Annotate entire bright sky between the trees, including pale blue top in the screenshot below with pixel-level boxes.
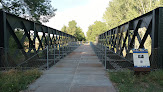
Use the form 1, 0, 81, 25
45, 0, 110, 35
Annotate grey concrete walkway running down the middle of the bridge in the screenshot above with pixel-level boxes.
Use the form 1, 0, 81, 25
29, 45, 115, 92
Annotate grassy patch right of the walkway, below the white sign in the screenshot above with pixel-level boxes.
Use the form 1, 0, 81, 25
109, 70, 163, 92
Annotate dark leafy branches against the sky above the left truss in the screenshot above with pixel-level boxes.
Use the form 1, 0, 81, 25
1, 0, 56, 23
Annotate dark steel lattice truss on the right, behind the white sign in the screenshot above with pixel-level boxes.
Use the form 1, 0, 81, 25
98, 7, 163, 68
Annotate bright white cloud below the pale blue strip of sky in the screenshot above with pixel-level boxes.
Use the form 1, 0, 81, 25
45, 0, 110, 34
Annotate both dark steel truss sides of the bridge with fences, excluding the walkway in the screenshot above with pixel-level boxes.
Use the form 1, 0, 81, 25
0, 7, 163, 70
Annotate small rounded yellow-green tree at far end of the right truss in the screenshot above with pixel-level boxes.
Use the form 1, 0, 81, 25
87, 21, 107, 42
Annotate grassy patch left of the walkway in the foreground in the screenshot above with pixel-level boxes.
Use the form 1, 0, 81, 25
0, 69, 42, 92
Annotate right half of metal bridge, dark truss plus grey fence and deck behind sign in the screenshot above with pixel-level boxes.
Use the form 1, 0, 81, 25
92, 7, 163, 69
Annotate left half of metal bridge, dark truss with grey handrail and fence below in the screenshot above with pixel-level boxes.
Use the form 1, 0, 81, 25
0, 11, 79, 68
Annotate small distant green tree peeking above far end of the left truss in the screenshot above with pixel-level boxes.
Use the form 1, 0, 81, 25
61, 20, 85, 41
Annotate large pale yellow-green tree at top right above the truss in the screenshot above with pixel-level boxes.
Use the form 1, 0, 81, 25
103, 0, 163, 29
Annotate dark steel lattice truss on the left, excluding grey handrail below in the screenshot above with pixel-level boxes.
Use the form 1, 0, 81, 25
0, 11, 76, 67
